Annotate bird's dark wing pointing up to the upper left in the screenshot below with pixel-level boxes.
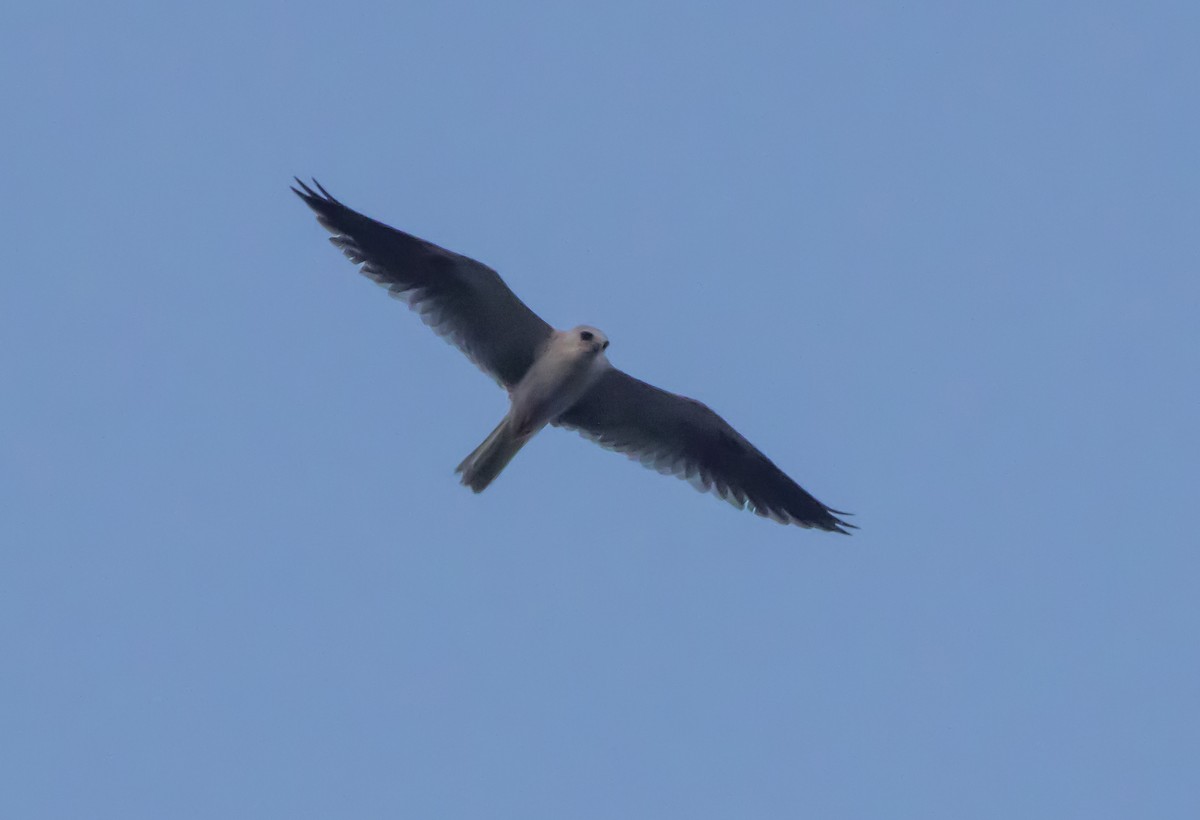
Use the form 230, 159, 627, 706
292, 179, 552, 388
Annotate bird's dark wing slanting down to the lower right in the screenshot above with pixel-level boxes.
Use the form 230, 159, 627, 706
554, 369, 854, 534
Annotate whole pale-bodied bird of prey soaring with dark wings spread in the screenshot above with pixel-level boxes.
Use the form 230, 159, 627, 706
292, 179, 854, 534
